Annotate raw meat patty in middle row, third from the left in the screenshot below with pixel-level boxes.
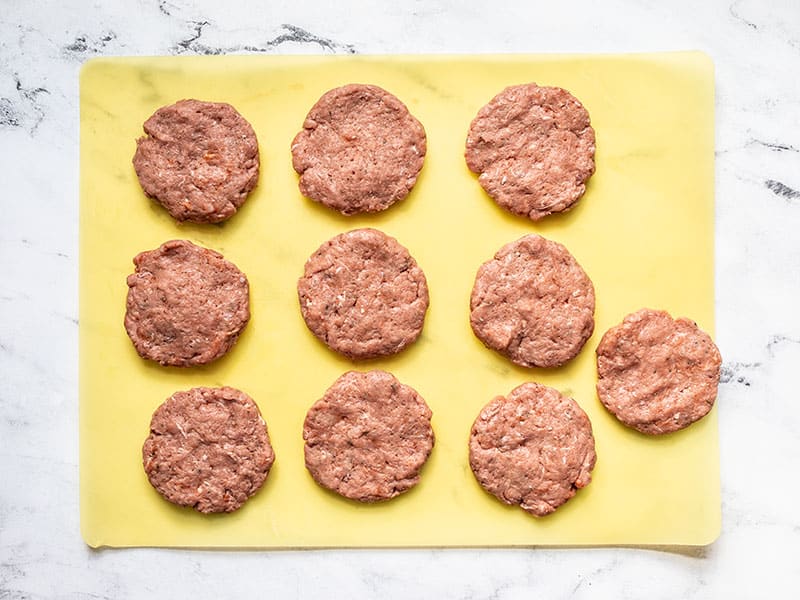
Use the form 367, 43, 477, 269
470, 235, 594, 367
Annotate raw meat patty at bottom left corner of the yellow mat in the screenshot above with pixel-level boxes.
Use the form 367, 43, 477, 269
142, 387, 275, 513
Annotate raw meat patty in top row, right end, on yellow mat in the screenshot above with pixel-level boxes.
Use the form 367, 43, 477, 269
466, 83, 595, 221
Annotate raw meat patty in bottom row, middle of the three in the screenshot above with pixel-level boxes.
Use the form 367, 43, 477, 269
303, 371, 434, 502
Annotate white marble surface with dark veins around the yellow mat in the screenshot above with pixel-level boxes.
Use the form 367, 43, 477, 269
0, 0, 800, 599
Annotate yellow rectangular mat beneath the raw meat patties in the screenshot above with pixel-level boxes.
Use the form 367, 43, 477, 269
80, 52, 720, 547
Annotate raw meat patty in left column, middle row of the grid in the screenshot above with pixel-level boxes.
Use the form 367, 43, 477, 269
125, 240, 250, 367
